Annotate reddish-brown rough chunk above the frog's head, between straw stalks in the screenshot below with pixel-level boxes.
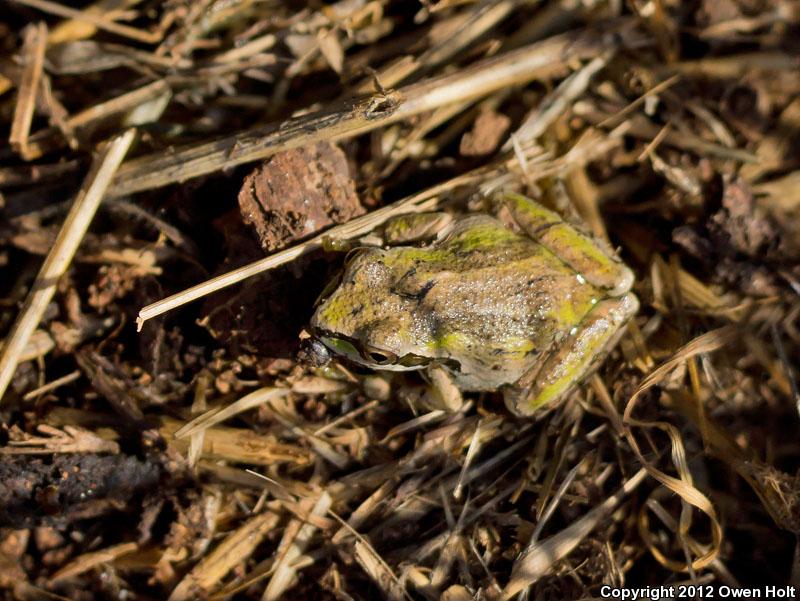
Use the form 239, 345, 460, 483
239, 142, 364, 251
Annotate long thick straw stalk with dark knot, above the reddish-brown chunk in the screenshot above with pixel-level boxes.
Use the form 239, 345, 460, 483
112, 25, 630, 196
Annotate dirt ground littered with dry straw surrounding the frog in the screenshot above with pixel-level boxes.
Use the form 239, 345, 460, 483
0, 0, 800, 601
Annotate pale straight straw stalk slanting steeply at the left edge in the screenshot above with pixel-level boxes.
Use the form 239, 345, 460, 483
0, 129, 136, 401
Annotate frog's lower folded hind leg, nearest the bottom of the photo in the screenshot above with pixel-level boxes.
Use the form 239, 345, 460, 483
504, 294, 639, 415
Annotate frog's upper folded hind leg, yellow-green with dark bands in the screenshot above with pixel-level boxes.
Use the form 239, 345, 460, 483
503, 193, 633, 296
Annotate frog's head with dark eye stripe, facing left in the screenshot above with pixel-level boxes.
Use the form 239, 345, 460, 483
310, 248, 438, 371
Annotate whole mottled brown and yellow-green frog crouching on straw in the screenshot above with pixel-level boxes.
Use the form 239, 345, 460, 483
310, 192, 639, 416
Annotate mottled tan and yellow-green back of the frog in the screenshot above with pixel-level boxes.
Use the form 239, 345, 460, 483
393, 215, 598, 389
